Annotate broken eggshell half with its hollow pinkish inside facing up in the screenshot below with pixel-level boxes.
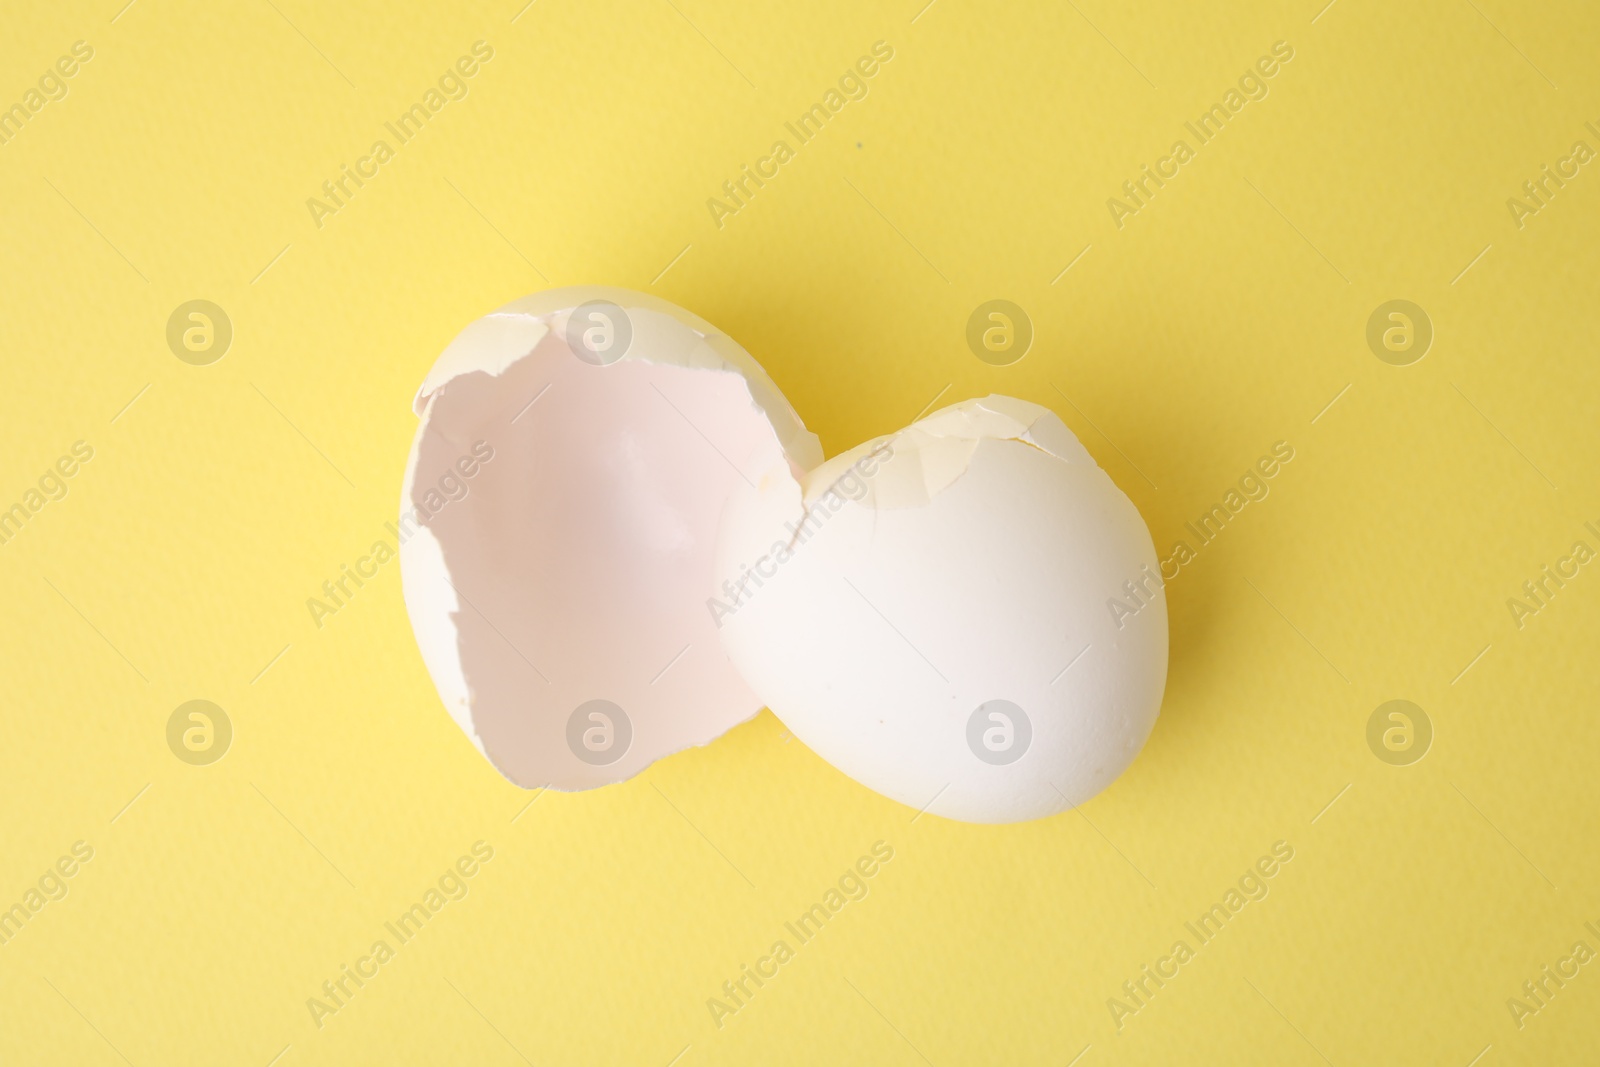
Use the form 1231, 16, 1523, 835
400, 286, 822, 789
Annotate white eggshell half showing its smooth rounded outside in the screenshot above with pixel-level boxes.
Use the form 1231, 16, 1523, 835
712, 397, 1166, 822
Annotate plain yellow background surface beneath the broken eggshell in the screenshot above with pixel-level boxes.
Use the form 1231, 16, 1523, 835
0, 0, 1600, 1067
